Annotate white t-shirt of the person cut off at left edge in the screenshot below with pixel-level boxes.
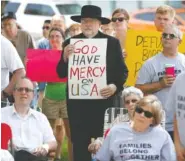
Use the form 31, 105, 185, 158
1, 35, 24, 91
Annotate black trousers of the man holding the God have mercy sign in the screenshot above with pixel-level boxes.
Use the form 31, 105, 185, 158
67, 99, 113, 161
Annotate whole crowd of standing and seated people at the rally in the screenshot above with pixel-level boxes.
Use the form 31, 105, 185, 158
1, 5, 185, 161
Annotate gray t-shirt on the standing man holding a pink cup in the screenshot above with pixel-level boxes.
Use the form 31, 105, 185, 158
136, 53, 185, 131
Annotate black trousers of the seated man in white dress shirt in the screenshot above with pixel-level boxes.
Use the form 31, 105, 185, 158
14, 150, 48, 161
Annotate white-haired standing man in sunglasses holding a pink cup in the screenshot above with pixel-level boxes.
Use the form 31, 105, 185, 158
136, 24, 185, 138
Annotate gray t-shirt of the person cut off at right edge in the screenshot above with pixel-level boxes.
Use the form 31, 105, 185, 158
166, 72, 185, 148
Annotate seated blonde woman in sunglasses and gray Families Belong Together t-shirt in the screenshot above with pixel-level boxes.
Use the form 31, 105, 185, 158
95, 95, 176, 161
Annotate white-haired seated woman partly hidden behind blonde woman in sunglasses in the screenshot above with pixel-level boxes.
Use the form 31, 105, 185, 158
88, 86, 143, 153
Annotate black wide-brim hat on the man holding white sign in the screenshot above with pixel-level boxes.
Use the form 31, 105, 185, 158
71, 5, 110, 24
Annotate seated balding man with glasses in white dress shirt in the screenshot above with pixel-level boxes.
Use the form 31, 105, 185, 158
1, 78, 57, 161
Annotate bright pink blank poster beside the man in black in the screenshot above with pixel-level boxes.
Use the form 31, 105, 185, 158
26, 49, 67, 82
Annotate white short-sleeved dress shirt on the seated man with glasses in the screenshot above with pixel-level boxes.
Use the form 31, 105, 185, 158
1, 106, 56, 153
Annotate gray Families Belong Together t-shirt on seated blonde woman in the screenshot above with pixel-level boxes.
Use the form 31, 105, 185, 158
95, 123, 176, 161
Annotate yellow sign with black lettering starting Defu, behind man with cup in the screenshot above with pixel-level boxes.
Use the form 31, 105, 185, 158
125, 30, 185, 86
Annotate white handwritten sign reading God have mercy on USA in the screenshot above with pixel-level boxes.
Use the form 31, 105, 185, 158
68, 39, 107, 99
